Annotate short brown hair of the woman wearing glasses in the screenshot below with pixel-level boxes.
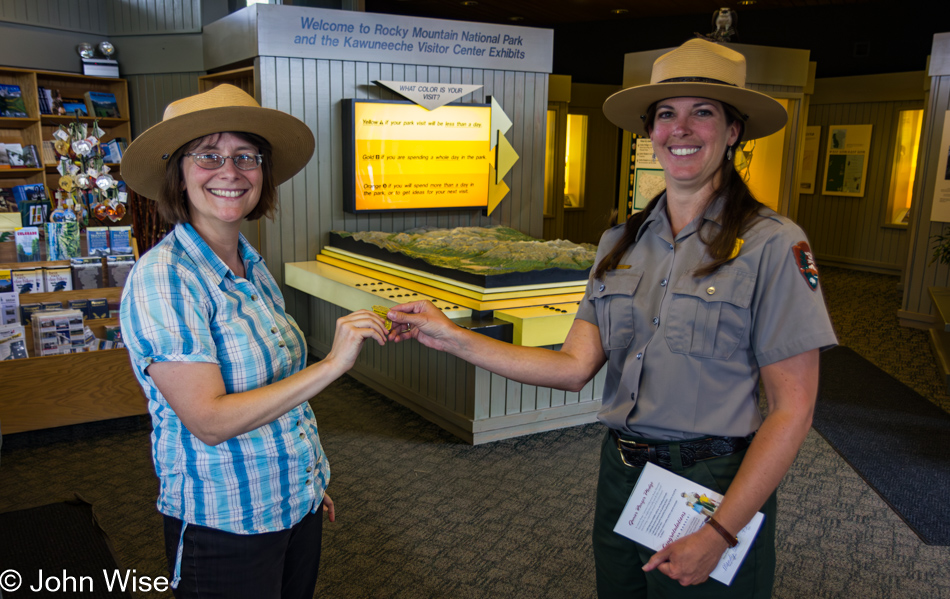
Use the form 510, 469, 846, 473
155, 131, 277, 224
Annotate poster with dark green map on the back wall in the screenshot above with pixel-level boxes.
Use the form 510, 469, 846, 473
821, 125, 871, 198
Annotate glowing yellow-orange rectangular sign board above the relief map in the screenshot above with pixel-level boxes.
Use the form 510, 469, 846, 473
343, 100, 493, 212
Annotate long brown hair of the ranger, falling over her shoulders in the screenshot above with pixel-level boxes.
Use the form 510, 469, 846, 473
594, 102, 763, 279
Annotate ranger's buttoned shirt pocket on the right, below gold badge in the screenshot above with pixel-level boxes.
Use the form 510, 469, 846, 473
666, 267, 756, 360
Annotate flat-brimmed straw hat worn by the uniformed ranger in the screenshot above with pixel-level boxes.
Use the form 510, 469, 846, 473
604, 38, 788, 141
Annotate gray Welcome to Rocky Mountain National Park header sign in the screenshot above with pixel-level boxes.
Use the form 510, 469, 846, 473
245, 4, 554, 73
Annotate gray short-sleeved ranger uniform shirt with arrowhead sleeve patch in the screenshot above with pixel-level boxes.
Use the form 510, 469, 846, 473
577, 195, 837, 440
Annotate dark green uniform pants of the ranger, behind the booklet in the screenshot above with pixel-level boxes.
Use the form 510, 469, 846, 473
593, 431, 777, 599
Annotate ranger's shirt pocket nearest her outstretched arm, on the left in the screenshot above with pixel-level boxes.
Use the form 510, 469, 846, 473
588, 270, 643, 351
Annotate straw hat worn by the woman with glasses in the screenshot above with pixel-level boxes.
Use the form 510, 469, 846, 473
122, 84, 314, 200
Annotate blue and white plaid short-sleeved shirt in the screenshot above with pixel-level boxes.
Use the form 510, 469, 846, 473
120, 224, 330, 534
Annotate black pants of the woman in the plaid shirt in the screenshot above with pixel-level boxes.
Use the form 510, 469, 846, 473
165, 509, 323, 599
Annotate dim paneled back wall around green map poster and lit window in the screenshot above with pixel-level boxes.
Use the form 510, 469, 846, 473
796, 99, 923, 274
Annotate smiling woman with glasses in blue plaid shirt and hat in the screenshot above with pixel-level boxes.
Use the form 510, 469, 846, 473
121, 85, 386, 599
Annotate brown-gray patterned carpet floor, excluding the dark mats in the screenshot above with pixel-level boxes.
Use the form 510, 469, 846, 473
0, 268, 950, 599
